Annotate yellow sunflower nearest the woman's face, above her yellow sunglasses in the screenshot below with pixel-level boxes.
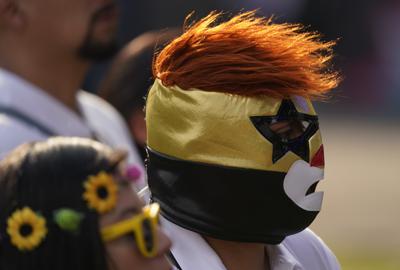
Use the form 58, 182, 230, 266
83, 172, 118, 214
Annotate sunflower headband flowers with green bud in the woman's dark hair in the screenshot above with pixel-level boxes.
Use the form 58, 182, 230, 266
7, 167, 139, 251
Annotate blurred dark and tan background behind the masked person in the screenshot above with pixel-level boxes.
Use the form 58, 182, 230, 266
83, 0, 400, 270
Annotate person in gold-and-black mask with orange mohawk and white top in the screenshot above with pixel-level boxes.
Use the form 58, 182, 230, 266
146, 12, 340, 270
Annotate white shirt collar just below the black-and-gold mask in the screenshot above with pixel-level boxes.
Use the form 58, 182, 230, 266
161, 218, 303, 270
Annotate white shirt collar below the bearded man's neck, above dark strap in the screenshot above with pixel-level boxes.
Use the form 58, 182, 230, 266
0, 68, 92, 137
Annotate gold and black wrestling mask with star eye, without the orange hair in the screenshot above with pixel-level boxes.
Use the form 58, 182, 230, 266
146, 80, 324, 244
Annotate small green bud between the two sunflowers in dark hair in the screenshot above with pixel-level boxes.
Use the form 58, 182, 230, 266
53, 208, 85, 233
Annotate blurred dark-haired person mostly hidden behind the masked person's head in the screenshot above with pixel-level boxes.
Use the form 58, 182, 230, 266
98, 29, 179, 160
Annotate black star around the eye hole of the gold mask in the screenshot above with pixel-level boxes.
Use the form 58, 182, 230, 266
250, 99, 319, 163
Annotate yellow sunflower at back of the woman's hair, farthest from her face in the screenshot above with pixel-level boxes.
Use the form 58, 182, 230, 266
7, 207, 47, 251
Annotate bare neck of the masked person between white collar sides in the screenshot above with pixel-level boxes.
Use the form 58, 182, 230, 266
205, 237, 270, 270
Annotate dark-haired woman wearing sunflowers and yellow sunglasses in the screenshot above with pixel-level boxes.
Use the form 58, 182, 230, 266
0, 137, 171, 270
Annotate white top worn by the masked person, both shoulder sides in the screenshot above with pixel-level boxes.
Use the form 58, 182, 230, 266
162, 218, 340, 270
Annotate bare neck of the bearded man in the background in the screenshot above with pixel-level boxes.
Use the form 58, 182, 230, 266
0, 46, 89, 113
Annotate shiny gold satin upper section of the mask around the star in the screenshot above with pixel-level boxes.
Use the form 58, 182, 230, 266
146, 80, 322, 172
